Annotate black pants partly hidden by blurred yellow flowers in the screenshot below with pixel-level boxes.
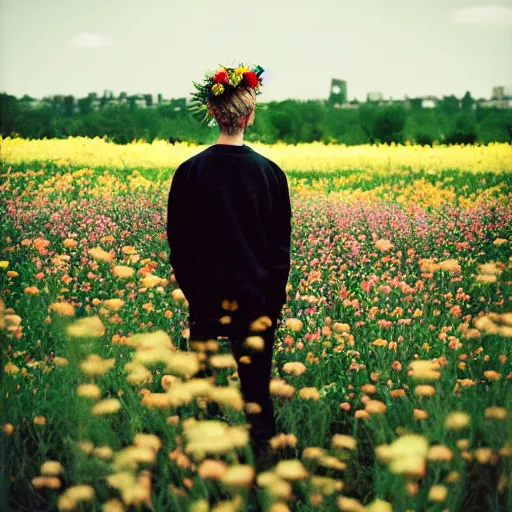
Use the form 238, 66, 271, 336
189, 315, 276, 445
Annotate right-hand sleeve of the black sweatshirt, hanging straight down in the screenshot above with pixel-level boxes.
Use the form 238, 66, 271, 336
268, 171, 292, 315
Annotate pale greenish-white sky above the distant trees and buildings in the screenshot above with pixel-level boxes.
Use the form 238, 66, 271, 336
0, 0, 512, 102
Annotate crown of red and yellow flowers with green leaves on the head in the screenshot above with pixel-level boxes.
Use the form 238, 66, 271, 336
189, 64, 264, 126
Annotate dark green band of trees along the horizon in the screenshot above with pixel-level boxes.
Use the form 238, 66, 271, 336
0, 93, 512, 145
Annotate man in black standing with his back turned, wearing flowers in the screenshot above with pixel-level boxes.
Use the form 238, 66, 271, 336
167, 67, 292, 464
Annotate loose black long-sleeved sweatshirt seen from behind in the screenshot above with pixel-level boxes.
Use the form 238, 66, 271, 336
167, 144, 292, 318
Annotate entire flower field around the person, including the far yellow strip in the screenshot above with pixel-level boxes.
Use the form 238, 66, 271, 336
0, 139, 512, 512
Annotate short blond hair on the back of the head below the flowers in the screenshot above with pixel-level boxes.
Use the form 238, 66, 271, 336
208, 87, 256, 135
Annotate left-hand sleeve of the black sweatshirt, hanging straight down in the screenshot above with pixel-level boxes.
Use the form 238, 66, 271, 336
167, 166, 196, 302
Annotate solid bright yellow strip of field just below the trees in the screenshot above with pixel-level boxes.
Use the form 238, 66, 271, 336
0, 137, 512, 173
